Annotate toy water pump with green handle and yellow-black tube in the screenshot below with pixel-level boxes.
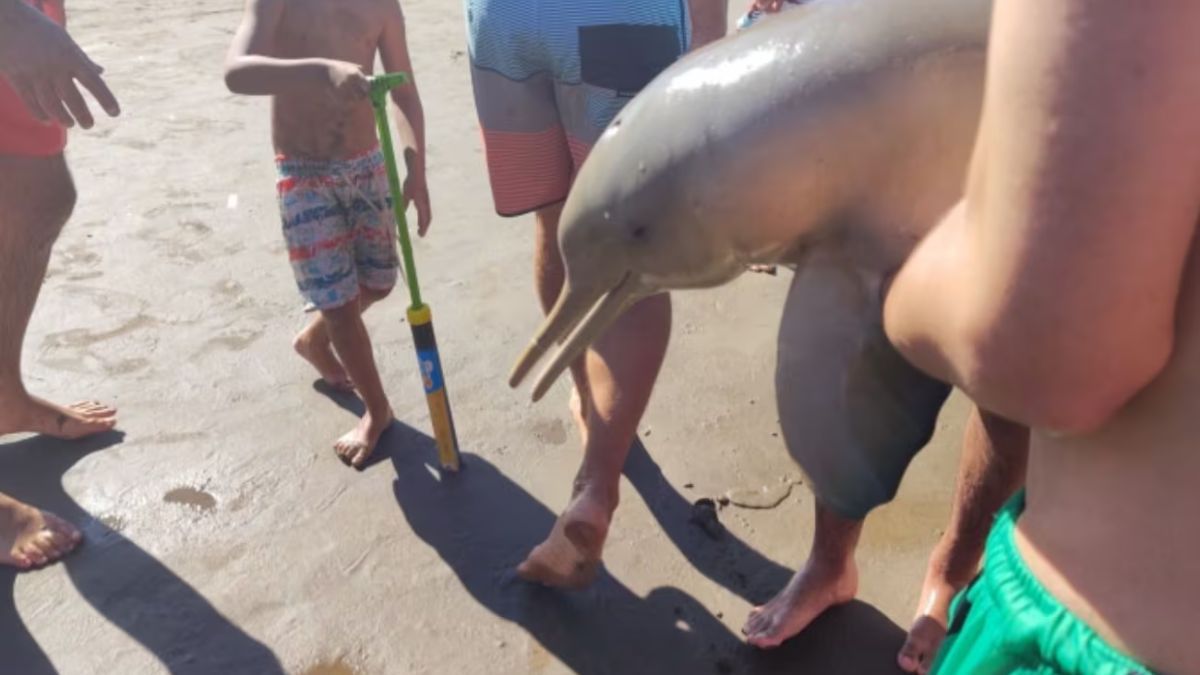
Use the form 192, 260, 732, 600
371, 72, 462, 471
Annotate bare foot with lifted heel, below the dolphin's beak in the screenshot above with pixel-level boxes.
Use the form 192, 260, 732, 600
517, 488, 617, 591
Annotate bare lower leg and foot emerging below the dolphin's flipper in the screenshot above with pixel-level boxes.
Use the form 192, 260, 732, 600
742, 501, 863, 649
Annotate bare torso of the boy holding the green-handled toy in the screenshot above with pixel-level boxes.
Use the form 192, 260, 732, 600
271, 0, 385, 159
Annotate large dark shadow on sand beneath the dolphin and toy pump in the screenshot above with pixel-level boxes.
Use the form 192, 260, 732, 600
376, 413, 904, 675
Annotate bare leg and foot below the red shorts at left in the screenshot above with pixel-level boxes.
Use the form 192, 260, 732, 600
0, 155, 116, 439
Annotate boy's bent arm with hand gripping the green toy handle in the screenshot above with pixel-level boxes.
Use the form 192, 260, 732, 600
226, 0, 371, 98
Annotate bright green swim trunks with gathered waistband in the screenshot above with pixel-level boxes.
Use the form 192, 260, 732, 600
930, 491, 1152, 675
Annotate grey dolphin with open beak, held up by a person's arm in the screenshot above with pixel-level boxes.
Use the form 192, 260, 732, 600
510, 0, 991, 518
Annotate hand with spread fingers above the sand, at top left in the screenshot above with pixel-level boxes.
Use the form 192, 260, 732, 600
0, 2, 121, 129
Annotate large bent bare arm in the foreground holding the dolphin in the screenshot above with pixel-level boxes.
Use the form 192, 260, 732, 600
884, 0, 1200, 431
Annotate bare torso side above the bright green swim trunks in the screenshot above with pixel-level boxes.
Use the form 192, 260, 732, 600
1016, 229, 1200, 674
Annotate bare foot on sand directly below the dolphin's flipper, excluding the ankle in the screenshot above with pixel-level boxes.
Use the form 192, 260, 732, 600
742, 560, 858, 649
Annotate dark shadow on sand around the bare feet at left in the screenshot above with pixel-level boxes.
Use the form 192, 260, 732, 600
0, 432, 283, 675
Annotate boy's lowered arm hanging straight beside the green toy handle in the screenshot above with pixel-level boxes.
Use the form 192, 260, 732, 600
379, 0, 432, 237
